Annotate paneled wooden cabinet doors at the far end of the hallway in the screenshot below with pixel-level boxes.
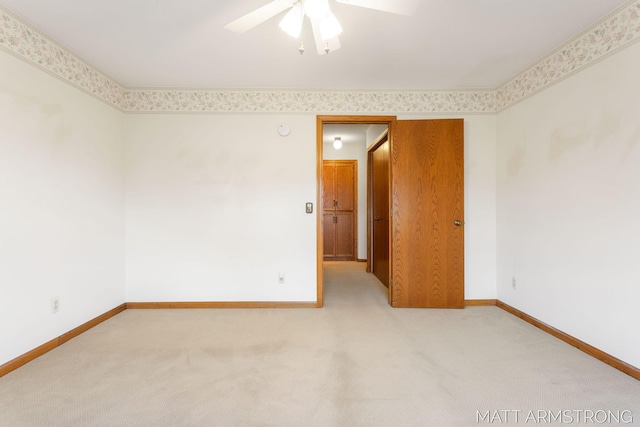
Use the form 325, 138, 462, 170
322, 160, 357, 261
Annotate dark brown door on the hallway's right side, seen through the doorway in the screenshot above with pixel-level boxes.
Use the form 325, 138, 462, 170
370, 140, 389, 287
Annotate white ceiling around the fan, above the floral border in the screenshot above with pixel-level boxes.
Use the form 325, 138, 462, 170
0, 0, 628, 90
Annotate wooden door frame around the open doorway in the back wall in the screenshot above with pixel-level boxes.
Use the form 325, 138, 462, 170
316, 115, 396, 308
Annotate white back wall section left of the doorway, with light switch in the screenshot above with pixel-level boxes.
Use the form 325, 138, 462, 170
126, 114, 317, 301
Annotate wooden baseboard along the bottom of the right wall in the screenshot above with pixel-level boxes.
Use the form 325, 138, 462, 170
496, 300, 640, 380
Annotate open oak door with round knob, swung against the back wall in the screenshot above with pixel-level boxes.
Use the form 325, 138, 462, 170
391, 119, 464, 308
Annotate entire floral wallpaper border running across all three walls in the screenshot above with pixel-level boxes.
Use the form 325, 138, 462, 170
0, 0, 640, 114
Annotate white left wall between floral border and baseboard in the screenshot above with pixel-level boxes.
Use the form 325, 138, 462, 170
0, 51, 125, 364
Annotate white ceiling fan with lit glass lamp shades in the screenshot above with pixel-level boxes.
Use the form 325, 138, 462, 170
225, 0, 420, 55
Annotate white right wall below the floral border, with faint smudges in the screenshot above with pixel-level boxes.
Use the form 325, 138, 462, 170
497, 44, 640, 367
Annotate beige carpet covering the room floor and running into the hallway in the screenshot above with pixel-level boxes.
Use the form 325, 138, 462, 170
0, 262, 640, 427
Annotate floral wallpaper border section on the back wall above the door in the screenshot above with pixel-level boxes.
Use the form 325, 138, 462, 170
124, 89, 496, 114
